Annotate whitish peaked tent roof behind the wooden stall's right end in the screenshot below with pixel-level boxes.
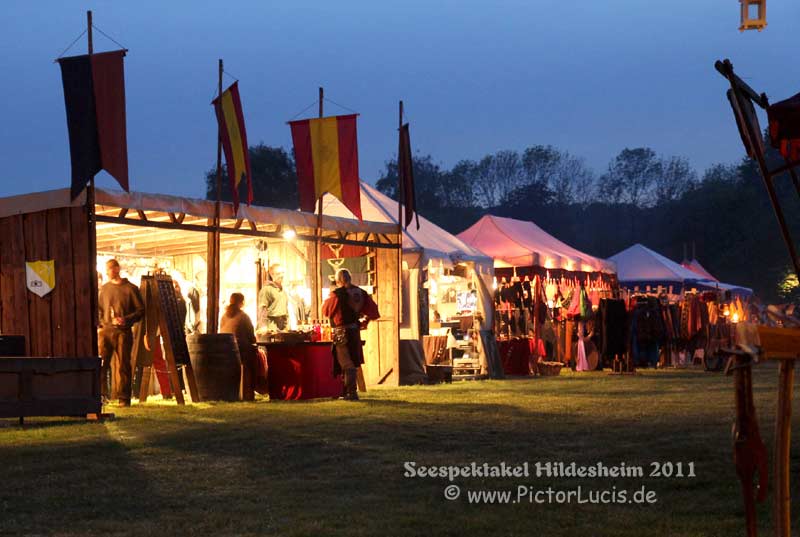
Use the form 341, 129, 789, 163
322, 181, 492, 268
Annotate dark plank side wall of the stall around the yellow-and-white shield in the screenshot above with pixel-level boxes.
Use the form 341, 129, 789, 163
0, 195, 97, 357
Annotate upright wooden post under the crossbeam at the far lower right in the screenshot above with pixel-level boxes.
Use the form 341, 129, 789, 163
773, 360, 794, 537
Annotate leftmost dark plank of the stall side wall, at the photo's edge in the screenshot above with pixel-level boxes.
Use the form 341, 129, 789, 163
0, 215, 30, 355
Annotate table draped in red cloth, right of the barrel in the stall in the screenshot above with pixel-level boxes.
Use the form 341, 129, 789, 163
258, 342, 342, 400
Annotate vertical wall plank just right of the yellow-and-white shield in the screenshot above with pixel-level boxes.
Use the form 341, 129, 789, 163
47, 209, 77, 356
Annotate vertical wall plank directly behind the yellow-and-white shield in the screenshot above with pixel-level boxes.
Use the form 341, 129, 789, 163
22, 211, 53, 356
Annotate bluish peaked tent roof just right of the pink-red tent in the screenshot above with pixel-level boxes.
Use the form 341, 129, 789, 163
608, 244, 753, 295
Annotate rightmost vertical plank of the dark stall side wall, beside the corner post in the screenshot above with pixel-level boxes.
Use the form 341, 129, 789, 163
70, 207, 97, 356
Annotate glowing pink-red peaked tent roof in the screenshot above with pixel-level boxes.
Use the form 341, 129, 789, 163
458, 215, 616, 274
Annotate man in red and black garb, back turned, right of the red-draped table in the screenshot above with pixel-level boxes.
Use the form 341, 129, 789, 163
322, 269, 380, 401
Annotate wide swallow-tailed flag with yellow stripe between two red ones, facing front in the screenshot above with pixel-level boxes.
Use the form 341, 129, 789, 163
289, 114, 361, 220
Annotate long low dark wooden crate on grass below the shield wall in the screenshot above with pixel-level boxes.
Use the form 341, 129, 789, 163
0, 357, 102, 418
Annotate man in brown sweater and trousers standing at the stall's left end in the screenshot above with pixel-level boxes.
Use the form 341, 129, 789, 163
97, 259, 144, 406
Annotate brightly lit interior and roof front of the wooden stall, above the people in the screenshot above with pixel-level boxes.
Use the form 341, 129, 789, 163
95, 190, 400, 384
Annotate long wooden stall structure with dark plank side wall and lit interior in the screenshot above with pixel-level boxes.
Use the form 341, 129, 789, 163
0, 189, 400, 385
